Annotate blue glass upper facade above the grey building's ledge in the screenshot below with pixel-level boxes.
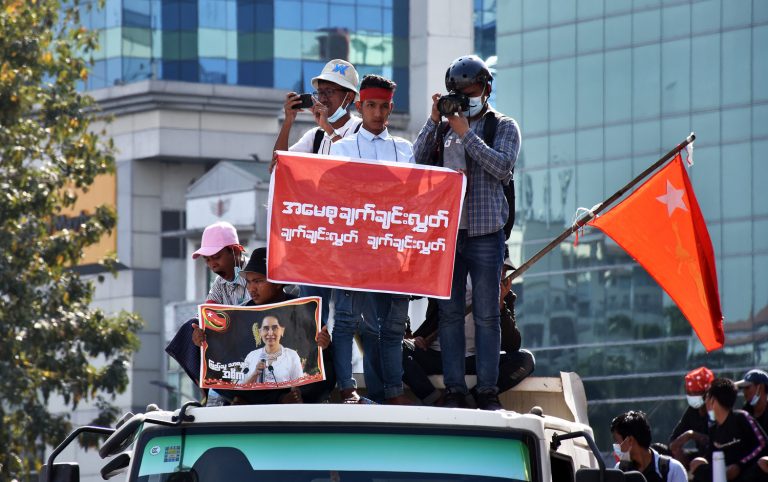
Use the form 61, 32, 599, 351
83, 0, 409, 110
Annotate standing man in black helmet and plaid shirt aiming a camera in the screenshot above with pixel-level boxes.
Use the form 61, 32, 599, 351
414, 55, 520, 410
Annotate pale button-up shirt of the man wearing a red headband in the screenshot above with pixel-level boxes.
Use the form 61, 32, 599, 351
331, 127, 413, 163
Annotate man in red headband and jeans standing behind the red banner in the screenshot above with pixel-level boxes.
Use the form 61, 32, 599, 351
331, 75, 413, 404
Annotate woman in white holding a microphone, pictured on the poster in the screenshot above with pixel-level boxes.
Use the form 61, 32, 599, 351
238, 316, 304, 385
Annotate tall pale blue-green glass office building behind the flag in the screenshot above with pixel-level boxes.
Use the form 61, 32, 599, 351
492, 0, 768, 450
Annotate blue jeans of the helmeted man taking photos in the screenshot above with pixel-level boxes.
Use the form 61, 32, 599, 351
437, 229, 504, 393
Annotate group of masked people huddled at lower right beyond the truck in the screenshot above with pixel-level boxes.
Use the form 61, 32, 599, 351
611, 367, 768, 482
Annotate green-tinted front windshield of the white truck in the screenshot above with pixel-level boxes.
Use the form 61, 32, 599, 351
132, 428, 532, 482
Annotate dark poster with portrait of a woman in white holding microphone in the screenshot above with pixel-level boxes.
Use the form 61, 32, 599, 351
198, 297, 325, 390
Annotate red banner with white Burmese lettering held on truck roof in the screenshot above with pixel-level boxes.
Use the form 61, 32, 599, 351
267, 151, 466, 298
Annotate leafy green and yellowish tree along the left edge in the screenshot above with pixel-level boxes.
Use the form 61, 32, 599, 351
0, 0, 140, 480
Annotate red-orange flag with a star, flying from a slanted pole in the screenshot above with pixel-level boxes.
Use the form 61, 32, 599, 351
590, 153, 725, 351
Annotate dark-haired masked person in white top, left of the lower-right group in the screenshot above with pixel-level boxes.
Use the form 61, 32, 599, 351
611, 411, 688, 482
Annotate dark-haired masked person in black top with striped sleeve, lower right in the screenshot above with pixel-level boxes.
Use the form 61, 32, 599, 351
691, 378, 768, 482
